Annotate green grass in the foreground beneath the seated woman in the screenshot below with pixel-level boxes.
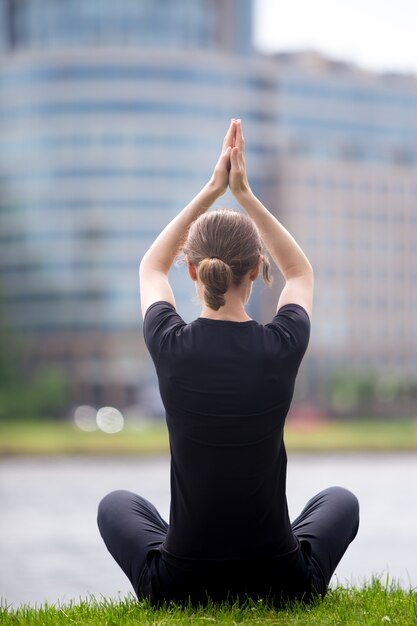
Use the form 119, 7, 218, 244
0, 579, 417, 626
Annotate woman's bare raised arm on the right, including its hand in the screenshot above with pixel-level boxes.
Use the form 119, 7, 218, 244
229, 121, 314, 316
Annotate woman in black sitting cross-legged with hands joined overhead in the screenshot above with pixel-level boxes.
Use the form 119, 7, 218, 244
98, 120, 359, 603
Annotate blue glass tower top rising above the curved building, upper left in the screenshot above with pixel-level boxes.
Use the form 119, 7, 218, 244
0, 0, 252, 55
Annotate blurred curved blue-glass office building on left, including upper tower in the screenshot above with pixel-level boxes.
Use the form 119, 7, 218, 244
0, 0, 276, 406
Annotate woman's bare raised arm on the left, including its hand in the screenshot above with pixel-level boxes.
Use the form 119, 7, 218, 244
139, 121, 234, 317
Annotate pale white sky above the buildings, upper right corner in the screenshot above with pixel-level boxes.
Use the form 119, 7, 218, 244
255, 0, 417, 74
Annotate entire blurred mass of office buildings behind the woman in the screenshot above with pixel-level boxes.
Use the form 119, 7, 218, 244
0, 0, 417, 406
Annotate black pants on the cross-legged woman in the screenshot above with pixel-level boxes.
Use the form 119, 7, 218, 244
98, 487, 359, 603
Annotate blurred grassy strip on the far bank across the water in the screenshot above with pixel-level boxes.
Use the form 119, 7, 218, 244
0, 419, 417, 456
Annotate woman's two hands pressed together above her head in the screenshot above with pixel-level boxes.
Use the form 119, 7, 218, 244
212, 119, 250, 197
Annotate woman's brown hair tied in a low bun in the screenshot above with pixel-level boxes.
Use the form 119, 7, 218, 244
183, 209, 271, 311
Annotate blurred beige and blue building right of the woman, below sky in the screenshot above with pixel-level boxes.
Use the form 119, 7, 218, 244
275, 53, 417, 399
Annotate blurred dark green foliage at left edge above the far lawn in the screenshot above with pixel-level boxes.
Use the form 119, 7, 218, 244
0, 298, 71, 420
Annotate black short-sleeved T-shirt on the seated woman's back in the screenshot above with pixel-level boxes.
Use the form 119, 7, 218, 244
144, 302, 309, 564
